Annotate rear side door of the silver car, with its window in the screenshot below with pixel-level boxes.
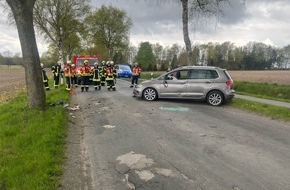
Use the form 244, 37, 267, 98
186, 69, 219, 99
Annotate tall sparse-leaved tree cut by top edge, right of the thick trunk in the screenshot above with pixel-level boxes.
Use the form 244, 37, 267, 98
34, 0, 90, 61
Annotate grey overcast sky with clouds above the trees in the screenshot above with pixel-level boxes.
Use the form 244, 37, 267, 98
0, 0, 290, 53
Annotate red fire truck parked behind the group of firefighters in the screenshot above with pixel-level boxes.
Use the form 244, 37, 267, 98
73, 55, 99, 84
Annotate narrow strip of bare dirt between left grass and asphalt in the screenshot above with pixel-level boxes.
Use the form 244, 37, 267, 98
59, 94, 92, 190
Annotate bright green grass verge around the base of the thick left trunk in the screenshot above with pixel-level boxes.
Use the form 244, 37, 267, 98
0, 86, 69, 190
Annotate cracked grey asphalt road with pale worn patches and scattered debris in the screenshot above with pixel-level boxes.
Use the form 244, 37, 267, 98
60, 80, 290, 190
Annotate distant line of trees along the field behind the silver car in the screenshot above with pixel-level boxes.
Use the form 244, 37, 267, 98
135, 42, 290, 71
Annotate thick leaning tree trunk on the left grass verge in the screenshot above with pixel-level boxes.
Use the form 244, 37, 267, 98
6, 0, 46, 110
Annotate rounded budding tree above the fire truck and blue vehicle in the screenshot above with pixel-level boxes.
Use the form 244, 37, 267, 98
85, 5, 133, 58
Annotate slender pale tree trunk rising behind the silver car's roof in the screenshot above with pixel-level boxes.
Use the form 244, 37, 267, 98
180, 0, 193, 65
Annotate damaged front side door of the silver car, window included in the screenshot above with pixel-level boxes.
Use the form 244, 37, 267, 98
159, 69, 188, 98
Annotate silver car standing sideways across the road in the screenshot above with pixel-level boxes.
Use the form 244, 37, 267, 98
133, 66, 235, 106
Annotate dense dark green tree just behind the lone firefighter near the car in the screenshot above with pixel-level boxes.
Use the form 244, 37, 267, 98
135, 42, 156, 71
